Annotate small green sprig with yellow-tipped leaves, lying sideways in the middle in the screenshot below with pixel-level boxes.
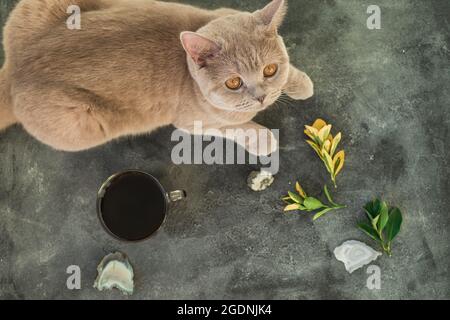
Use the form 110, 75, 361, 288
283, 182, 346, 221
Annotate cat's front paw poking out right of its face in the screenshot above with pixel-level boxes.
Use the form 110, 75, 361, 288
283, 65, 314, 100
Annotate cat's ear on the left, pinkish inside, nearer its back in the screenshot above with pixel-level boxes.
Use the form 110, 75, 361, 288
180, 31, 221, 67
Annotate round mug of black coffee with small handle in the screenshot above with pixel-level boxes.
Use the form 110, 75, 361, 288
97, 170, 186, 242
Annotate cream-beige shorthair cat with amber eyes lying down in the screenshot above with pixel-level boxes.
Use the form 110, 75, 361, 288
0, 0, 313, 155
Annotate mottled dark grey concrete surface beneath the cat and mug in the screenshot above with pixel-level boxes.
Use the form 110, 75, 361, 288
0, 0, 450, 299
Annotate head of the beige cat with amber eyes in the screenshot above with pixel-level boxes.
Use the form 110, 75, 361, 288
181, 0, 289, 112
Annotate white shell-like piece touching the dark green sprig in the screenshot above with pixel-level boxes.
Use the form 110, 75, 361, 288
334, 240, 382, 273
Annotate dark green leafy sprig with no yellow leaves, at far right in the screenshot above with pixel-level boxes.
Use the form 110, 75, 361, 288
358, 199, 403, 256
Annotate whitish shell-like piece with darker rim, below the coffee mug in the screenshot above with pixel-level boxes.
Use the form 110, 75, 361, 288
94, 252, 134, 295
